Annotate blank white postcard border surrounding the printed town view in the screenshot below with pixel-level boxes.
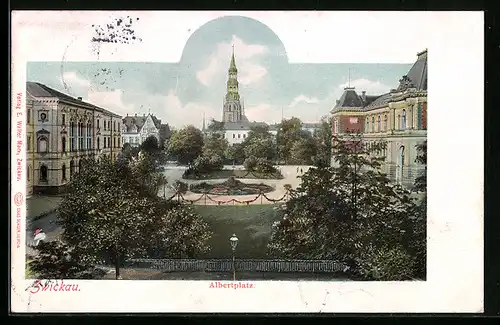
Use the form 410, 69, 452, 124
11, 11, 484, 313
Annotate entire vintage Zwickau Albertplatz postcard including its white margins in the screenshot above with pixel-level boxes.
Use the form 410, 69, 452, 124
11, 11, 484, 313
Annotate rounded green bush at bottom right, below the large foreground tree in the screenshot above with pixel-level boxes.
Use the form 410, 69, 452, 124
357, 247, 415, 281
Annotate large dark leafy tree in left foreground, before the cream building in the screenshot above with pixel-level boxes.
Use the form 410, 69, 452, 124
58, 156, 212, 278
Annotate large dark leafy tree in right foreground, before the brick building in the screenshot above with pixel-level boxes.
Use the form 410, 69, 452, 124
269, 135, 424, 277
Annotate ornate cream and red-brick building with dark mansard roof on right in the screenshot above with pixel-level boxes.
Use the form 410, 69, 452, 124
331, 50, 427, 187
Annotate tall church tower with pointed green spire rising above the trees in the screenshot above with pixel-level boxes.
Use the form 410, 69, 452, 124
222, 45, 247, 123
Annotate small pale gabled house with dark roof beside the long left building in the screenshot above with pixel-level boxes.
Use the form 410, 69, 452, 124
121, 114, 171, 147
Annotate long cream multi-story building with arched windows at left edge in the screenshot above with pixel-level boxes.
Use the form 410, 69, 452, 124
26, 82, 121, 195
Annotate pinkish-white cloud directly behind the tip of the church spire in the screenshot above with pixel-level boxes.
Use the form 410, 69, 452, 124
196, 35, 268, 86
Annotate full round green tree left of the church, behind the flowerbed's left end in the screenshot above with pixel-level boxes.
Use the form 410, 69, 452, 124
166, 125, 203, 165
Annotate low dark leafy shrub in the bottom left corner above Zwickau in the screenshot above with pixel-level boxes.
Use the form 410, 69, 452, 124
29, 240, 92, 279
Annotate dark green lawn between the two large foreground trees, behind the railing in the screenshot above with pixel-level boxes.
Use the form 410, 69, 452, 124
195, 204, 278, 259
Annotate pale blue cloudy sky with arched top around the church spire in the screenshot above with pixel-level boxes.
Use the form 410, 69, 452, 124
27, 16, 412, 127
